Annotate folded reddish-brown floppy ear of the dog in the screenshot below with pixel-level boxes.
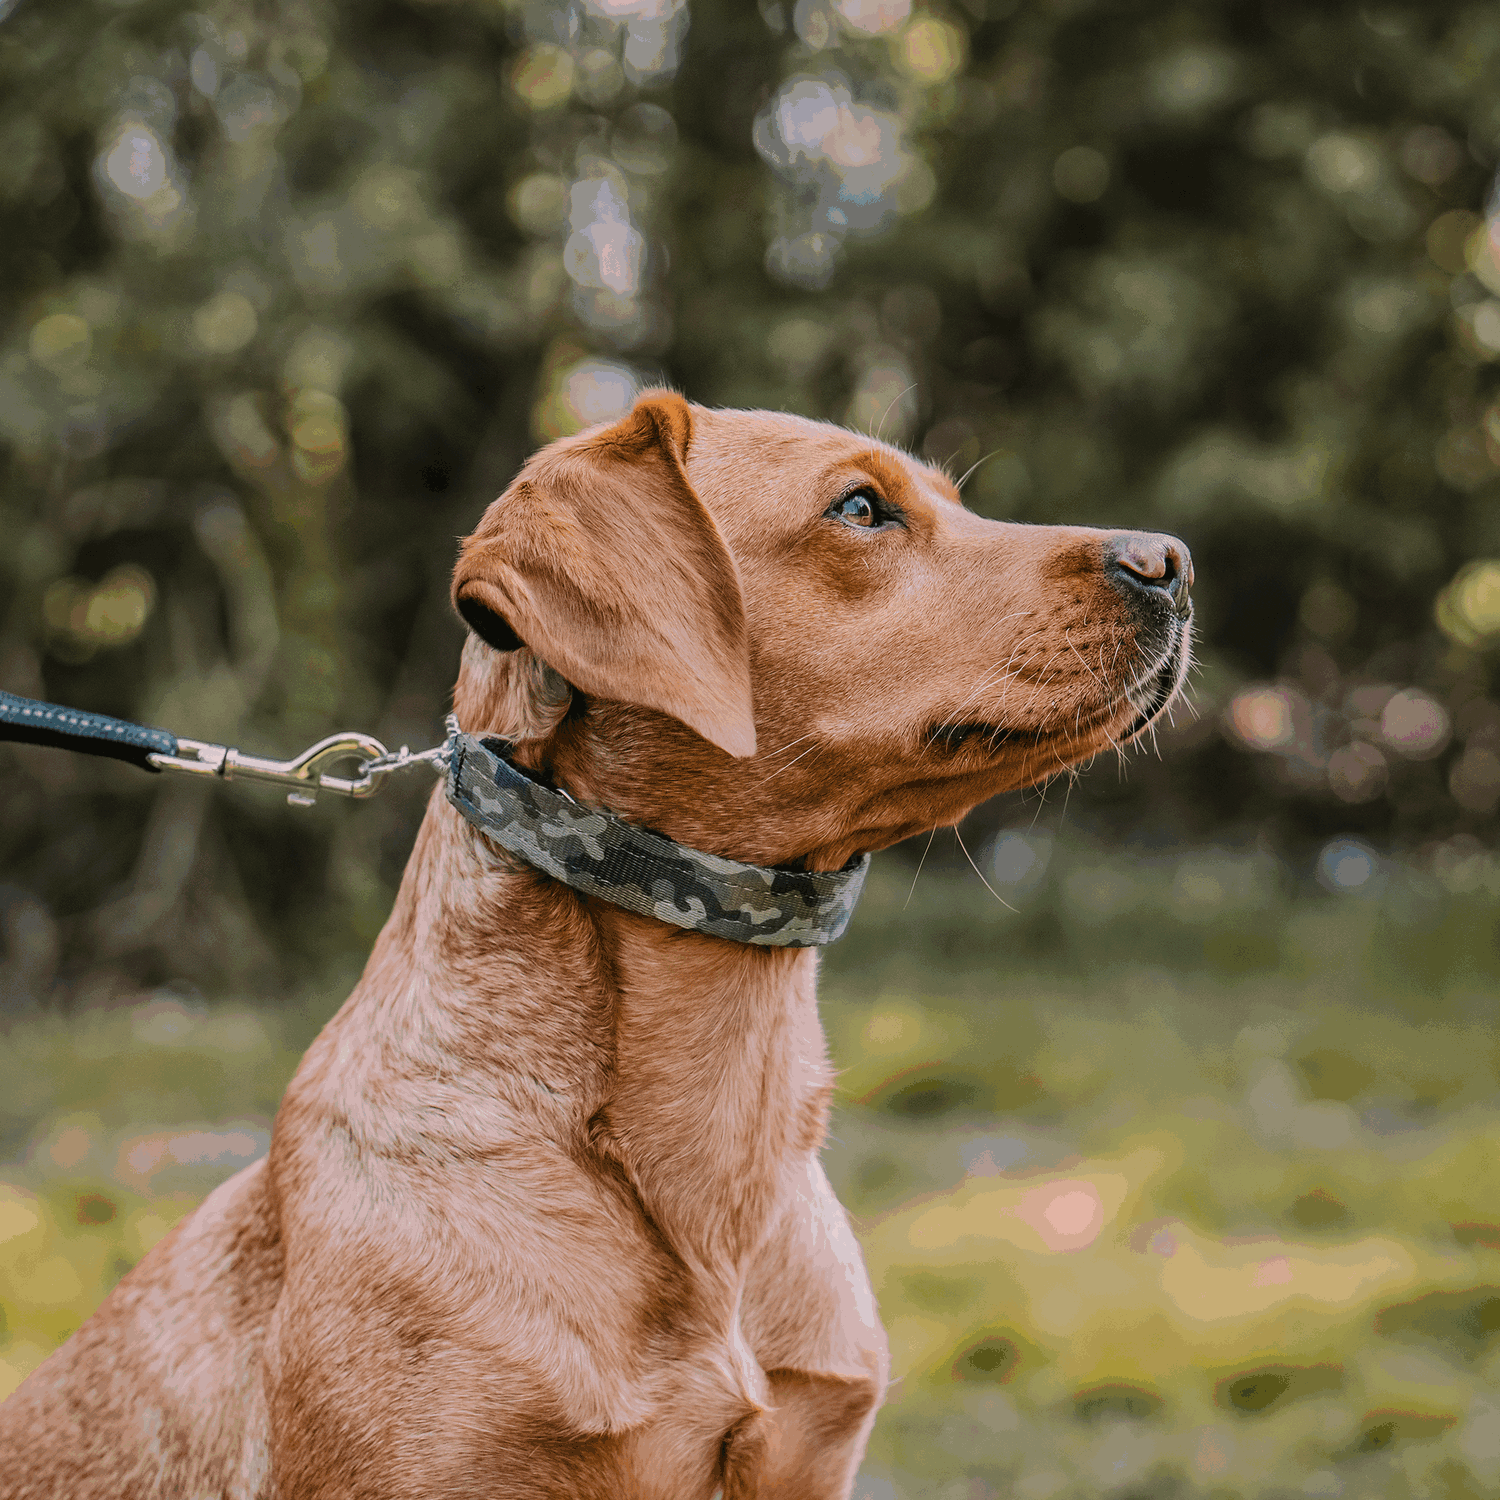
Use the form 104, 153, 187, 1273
453, 392, 755, 756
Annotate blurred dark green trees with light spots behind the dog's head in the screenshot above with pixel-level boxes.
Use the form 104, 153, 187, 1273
0, 0, 1500, 999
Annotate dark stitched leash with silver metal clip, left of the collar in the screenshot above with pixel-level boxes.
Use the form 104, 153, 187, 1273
0, 693, 444, 807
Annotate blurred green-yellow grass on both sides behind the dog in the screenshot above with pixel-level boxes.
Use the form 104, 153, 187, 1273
0, 846, 1500, 1500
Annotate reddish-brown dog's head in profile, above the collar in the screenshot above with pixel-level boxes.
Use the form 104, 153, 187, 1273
453, 392, 1193, 869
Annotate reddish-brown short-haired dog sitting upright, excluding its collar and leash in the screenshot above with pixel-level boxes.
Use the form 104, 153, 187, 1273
0, 392, 1191, 1500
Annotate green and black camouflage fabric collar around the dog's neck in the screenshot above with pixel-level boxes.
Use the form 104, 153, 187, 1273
449, 734, 870, 948
